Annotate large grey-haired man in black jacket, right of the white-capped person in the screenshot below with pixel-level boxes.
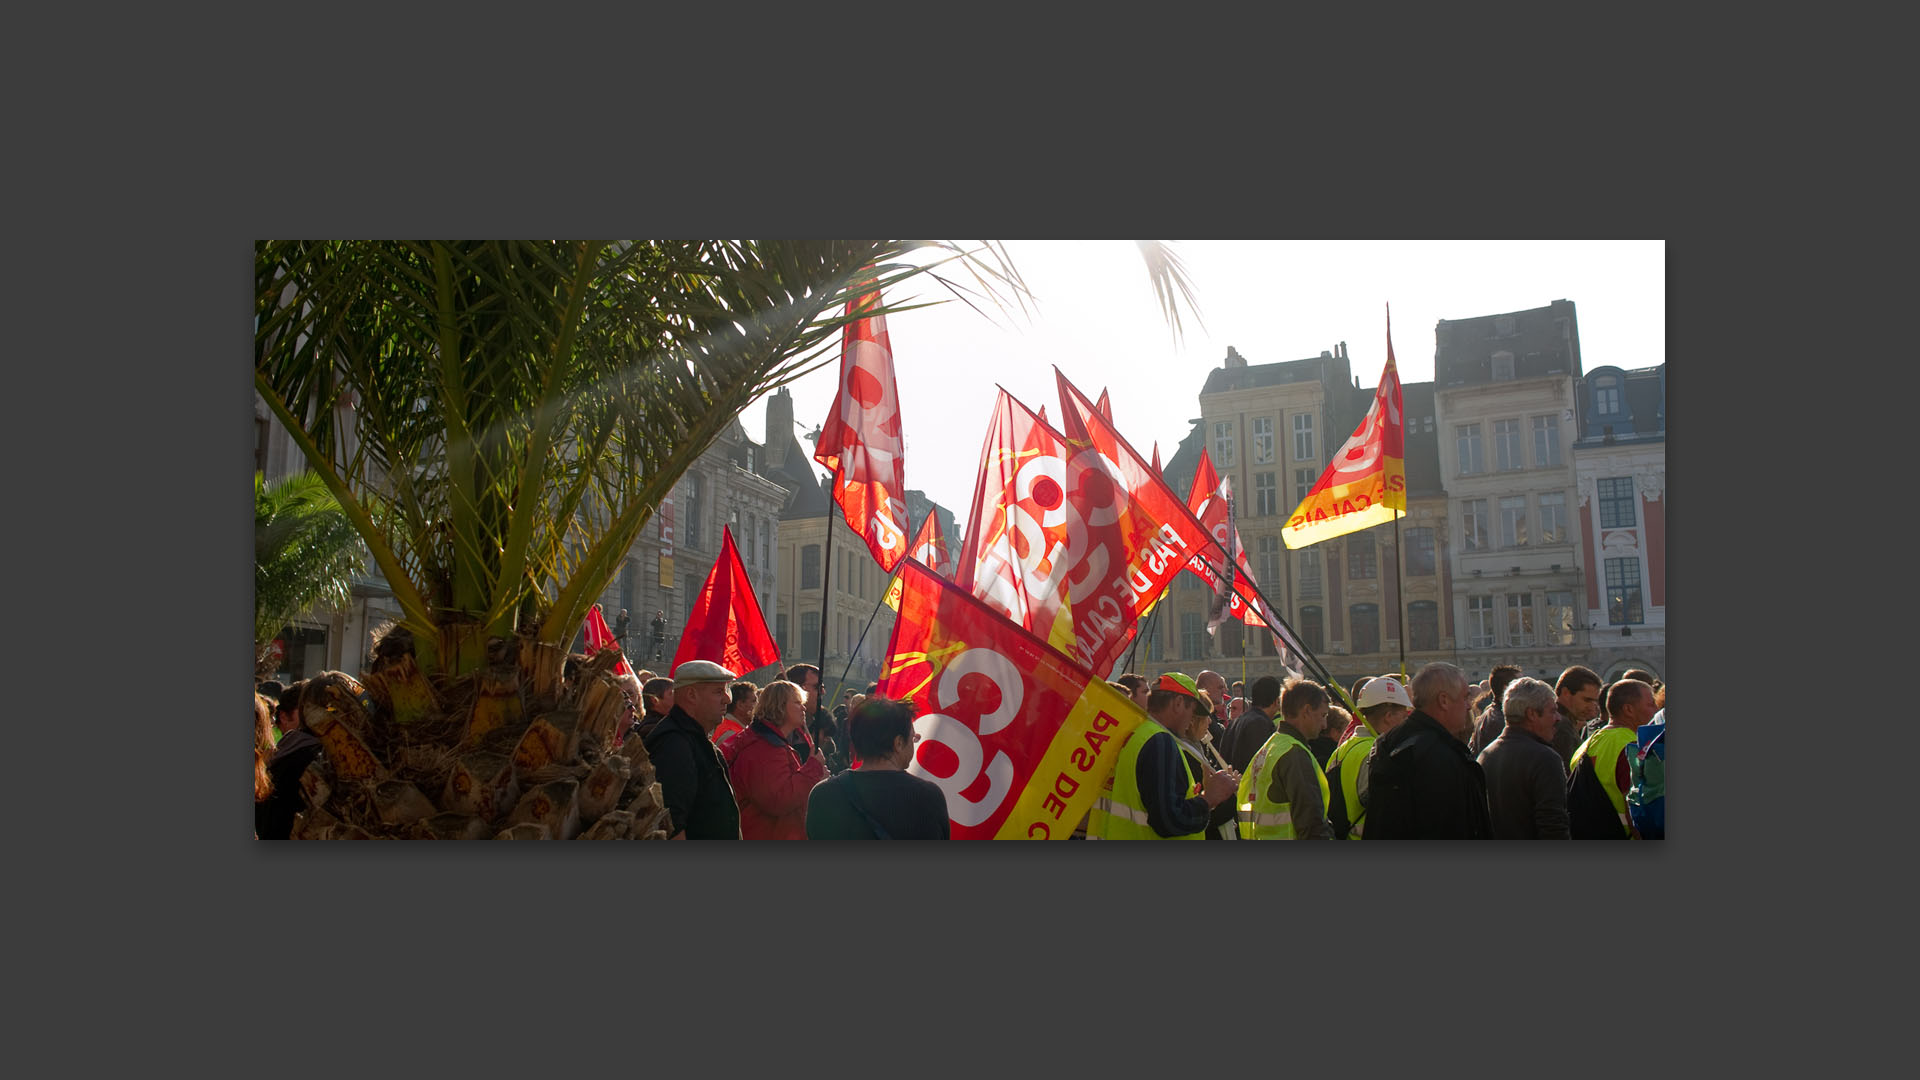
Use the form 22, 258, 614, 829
1365, 663, 1494, 840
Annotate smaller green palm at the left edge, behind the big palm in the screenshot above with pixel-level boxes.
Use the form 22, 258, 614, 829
253, 471, 367, 665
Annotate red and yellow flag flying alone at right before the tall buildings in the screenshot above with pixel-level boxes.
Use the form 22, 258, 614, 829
1281, 311, 1407, 548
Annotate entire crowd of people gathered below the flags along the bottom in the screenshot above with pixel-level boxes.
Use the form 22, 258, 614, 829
253, 645, 1667, 840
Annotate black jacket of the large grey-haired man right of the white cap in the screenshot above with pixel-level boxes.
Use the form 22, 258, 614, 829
1365, 709, 1494, 840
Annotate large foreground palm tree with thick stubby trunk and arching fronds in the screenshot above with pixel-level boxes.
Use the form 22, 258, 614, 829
253, 240, 1190, 836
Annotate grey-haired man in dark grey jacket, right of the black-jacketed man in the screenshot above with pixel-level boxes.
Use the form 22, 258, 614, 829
1478, 678, 1572, 840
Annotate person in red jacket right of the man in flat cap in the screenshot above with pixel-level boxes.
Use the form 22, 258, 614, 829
720, 680, 828, 840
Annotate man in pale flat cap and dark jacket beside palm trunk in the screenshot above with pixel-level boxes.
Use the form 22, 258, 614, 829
645, 659, 739, 840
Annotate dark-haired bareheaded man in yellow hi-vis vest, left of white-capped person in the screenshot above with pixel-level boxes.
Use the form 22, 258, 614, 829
1236, 678, 1332, 840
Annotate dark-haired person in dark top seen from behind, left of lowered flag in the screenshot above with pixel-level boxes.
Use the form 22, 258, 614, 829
806, 698, 952, 840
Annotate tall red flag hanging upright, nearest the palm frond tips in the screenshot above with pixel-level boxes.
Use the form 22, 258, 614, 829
814, 290, 906, 573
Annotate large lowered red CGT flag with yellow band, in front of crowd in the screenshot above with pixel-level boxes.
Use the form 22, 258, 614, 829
879, 559, 1146, 840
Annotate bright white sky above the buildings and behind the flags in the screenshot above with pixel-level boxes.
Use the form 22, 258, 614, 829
741, 240, 1667, 542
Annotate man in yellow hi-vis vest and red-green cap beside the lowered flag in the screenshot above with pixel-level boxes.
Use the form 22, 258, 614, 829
1087, 671, 1240, 840
